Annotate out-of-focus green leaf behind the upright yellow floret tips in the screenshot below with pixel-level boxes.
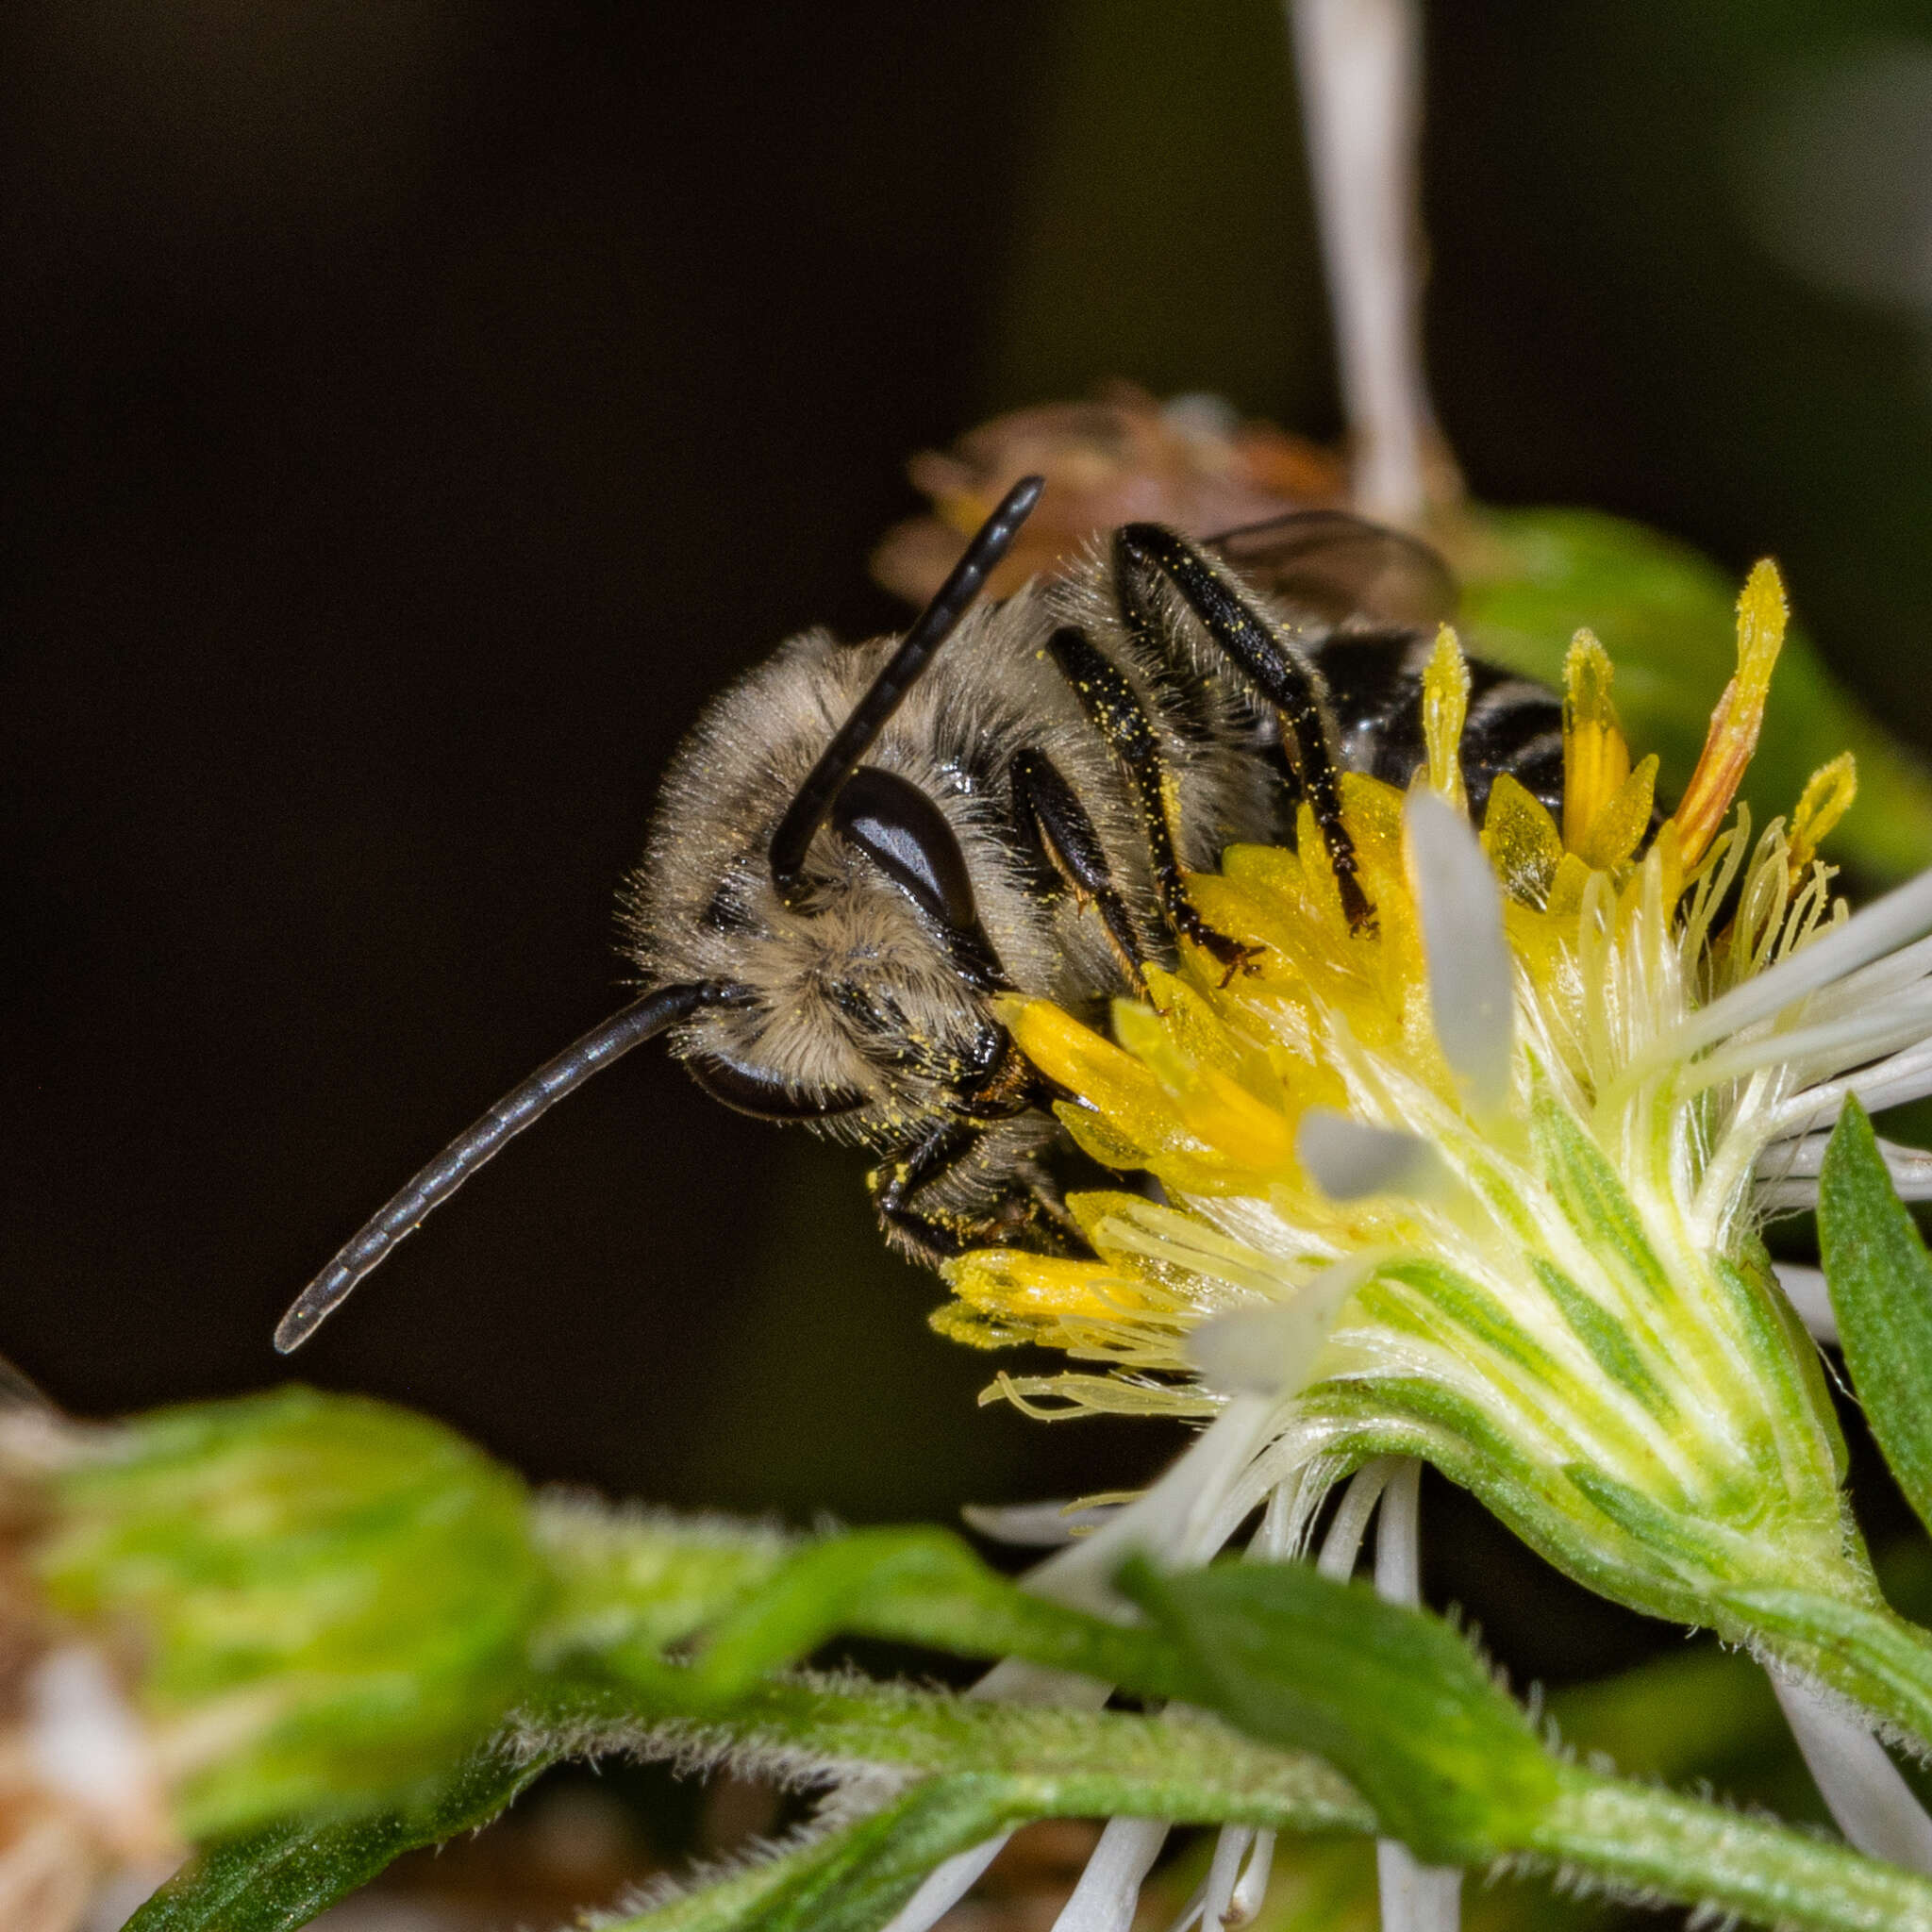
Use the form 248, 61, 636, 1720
1453, 510, 1932, 883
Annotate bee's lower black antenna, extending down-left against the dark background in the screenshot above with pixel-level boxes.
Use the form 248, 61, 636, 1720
275, 981, 738, 1355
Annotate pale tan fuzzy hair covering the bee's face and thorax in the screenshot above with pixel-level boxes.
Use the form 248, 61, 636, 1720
625, 553, 1279, 1194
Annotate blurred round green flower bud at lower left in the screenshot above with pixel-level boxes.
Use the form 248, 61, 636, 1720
37, 1387, 545, 1836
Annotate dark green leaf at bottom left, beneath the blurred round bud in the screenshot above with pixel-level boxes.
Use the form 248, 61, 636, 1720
125, 1748, 551, 1932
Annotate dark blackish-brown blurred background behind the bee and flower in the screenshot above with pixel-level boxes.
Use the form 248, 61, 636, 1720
0, 0, 1932, 1672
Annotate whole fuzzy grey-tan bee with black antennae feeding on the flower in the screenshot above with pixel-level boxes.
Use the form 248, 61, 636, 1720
276, 477, 1563, 1353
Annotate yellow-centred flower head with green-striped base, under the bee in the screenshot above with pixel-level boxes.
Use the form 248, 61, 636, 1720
935, 564, 1932, 1659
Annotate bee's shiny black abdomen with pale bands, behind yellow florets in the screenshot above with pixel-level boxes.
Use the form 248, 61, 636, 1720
1314, 630, 1563, 817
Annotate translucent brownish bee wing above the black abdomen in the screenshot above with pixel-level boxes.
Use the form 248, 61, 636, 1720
1208, 510, 1458, 626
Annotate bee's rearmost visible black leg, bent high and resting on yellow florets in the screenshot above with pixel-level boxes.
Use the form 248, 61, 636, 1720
1113, 524, 1375, 931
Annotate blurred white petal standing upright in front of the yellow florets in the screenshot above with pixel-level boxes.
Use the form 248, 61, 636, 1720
1403, 787, 1507, 1109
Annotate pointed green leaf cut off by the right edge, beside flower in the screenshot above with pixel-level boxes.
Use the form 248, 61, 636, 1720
1818, 1099, 1932, 1524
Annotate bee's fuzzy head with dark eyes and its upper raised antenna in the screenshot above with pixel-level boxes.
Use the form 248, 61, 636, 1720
626, 477, 1041, 1138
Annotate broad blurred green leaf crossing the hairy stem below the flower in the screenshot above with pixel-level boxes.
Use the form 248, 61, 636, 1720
1123, 1563, 1557, 1864
